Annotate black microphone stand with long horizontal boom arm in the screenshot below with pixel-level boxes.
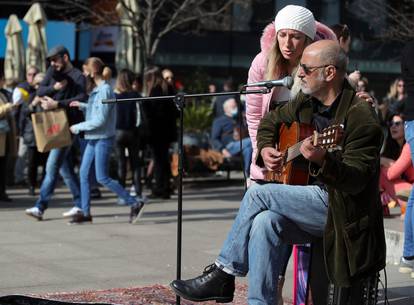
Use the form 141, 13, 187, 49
102, 85, 271, 305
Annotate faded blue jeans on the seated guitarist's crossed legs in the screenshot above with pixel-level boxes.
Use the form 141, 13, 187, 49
216, 184, 328, 305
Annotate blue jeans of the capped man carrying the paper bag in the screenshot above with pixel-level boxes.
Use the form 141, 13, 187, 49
36, 146, 81, 211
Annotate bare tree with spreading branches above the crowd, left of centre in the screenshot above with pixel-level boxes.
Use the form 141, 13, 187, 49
25, 0, 251, 70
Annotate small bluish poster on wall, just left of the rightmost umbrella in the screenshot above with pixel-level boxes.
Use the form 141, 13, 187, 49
91, 26, 119, 52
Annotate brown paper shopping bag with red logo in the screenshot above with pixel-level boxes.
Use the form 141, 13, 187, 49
32, 109, 72, 152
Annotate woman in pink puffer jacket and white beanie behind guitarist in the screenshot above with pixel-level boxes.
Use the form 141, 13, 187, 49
246, 5, 336, 180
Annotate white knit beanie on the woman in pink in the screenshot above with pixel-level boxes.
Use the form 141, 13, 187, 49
275, 5, 316, 40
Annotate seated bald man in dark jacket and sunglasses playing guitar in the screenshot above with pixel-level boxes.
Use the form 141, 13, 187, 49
171, 40, 385, 305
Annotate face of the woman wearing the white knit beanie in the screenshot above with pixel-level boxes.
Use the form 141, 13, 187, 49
277, 29, 306, 64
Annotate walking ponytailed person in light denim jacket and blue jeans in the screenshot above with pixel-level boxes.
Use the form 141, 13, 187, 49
70, 57, 144, 224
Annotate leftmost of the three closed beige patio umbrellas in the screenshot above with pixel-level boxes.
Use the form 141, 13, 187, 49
4, 14, 25, 82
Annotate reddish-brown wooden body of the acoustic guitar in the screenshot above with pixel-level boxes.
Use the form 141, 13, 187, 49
265, 122, 314, 185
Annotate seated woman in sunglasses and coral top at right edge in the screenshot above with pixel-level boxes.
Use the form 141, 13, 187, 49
380, 114, 414, 217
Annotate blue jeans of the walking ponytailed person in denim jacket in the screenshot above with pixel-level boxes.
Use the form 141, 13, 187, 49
79, 137, 137, 216
